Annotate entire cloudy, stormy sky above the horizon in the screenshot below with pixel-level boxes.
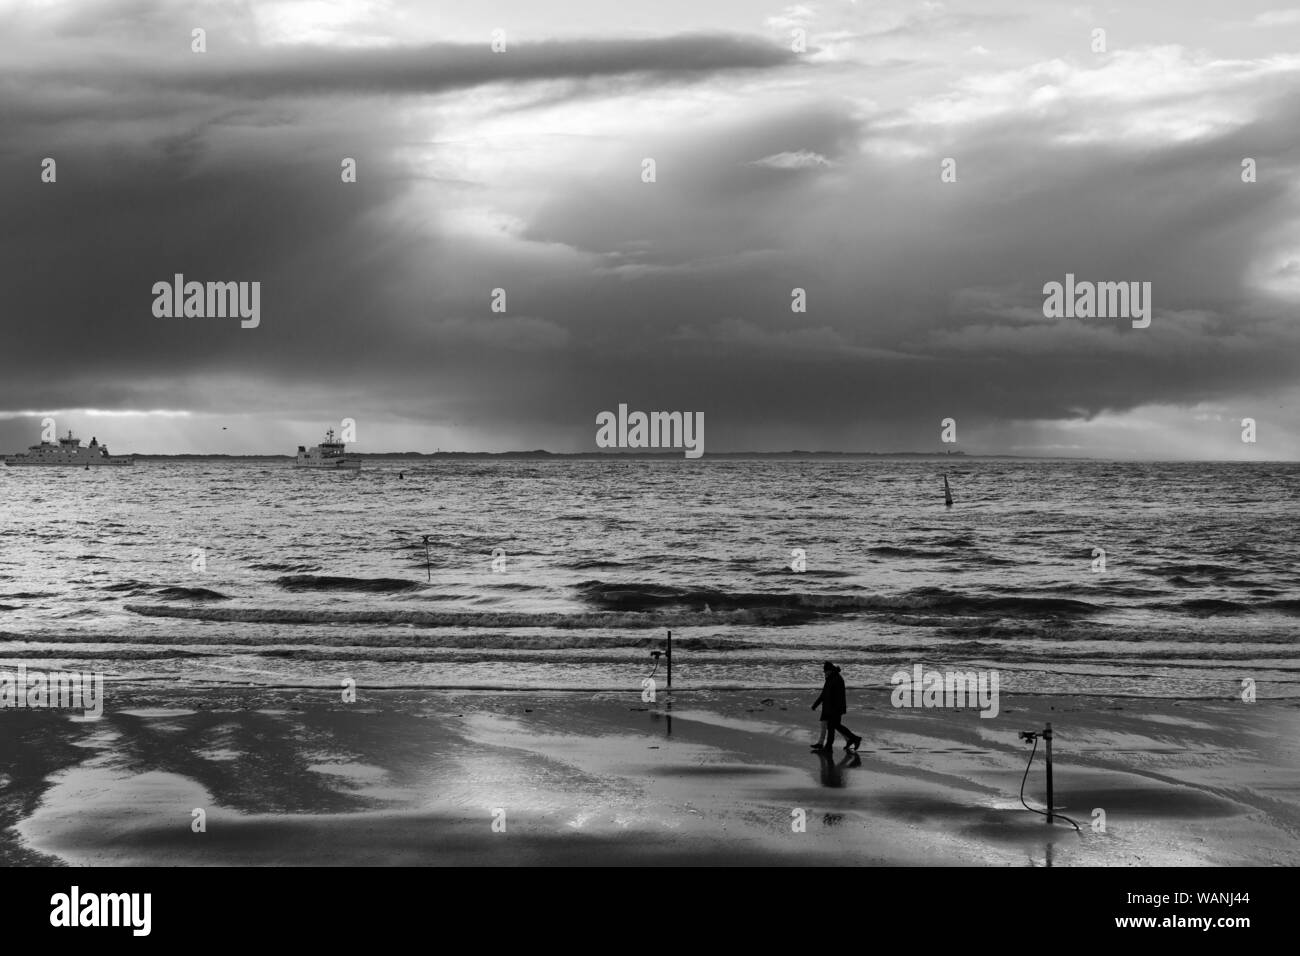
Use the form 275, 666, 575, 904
0, 0, 1300, 459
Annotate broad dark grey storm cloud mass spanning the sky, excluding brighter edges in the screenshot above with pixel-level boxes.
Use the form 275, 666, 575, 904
0, 3, 1300, 450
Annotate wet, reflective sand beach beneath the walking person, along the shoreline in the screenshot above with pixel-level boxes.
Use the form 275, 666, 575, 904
0, 685, 1300, 866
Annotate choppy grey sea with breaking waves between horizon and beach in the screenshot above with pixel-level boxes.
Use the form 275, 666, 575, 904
0, 459, 1300, 697
